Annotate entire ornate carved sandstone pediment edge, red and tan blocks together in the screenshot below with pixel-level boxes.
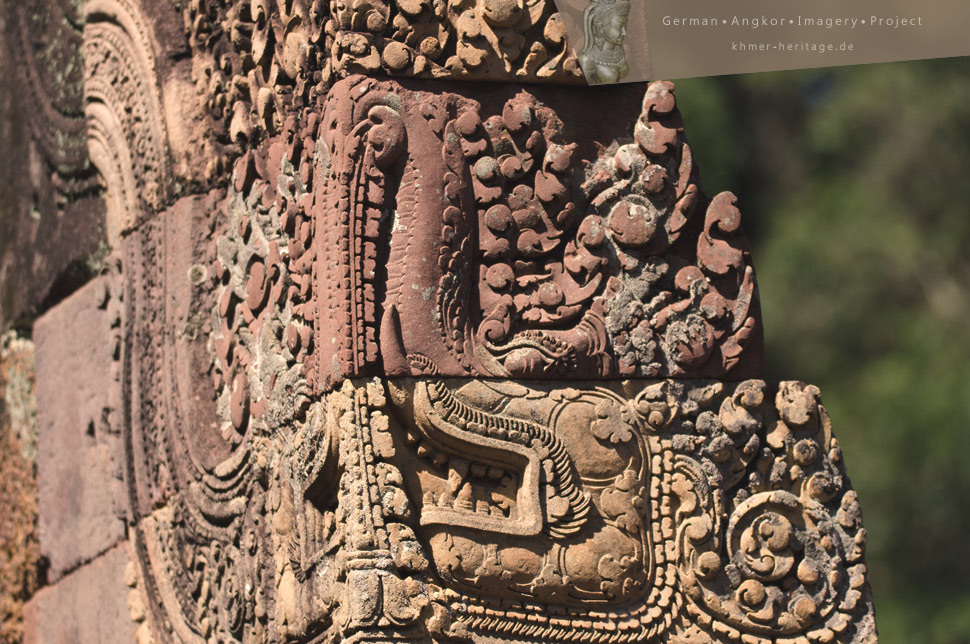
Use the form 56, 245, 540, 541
20, 0, 875, 644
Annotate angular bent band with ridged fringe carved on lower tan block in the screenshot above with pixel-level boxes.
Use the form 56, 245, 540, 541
415, 380, 590, 537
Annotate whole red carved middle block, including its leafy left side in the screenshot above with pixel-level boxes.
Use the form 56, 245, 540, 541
204, 77, 763, 406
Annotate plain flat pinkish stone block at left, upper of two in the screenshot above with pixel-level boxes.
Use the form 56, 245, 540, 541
34, 274, 125, 581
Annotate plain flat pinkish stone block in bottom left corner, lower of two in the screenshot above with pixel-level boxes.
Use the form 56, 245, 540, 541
24, 543, 136, 644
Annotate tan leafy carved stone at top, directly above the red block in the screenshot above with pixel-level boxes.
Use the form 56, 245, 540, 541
184, 0, 584, 177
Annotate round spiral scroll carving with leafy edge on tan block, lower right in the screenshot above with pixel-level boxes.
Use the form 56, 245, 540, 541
678, 383, 865, 641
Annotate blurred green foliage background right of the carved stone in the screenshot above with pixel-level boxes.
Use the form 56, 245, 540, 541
677, 58, 970, 644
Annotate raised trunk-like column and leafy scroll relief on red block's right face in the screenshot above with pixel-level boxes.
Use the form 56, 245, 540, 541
303, 78, 761, 388
